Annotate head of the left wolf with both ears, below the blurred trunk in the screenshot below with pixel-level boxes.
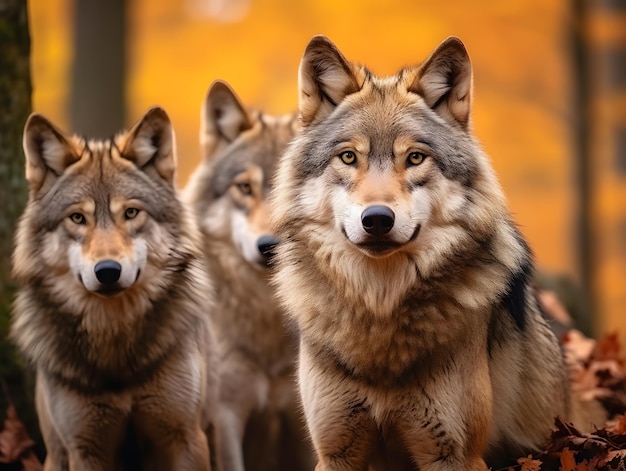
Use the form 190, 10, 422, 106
13, 107, 194, 302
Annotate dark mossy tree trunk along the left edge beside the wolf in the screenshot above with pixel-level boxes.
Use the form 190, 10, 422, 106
0, 0, 43, 456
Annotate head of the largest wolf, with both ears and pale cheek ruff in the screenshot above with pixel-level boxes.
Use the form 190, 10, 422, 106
273, 36, 506, 275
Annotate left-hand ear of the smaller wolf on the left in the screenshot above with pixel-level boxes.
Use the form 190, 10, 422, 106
22, 113, 80, 191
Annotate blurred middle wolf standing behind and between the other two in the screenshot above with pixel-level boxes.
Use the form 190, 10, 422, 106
184, 80, 313, 471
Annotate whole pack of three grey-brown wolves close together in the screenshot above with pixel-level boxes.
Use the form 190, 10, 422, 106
11, 36, 571, 471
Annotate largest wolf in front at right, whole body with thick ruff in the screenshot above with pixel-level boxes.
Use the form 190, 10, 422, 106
270, 36, 569, 471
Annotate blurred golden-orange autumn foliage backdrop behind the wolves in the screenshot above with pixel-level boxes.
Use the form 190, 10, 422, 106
29, 0, 626, 340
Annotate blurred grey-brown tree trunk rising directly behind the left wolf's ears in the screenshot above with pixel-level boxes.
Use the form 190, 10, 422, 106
71, 0, 126, 138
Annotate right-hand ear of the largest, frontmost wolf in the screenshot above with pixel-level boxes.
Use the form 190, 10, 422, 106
409, 37, 472, 129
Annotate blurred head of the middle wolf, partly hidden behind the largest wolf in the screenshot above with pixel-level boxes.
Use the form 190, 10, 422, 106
185, 81, 296, 267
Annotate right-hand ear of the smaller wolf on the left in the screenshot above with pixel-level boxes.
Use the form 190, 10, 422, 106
122, 106, 176, 185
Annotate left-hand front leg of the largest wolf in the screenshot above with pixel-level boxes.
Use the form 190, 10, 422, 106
299, 345, 378, 471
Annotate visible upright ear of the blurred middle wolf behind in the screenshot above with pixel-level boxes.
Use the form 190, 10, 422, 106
200, 80, 252, 154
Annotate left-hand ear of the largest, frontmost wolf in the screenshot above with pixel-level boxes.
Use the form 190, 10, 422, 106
298, 35, 363, 127
